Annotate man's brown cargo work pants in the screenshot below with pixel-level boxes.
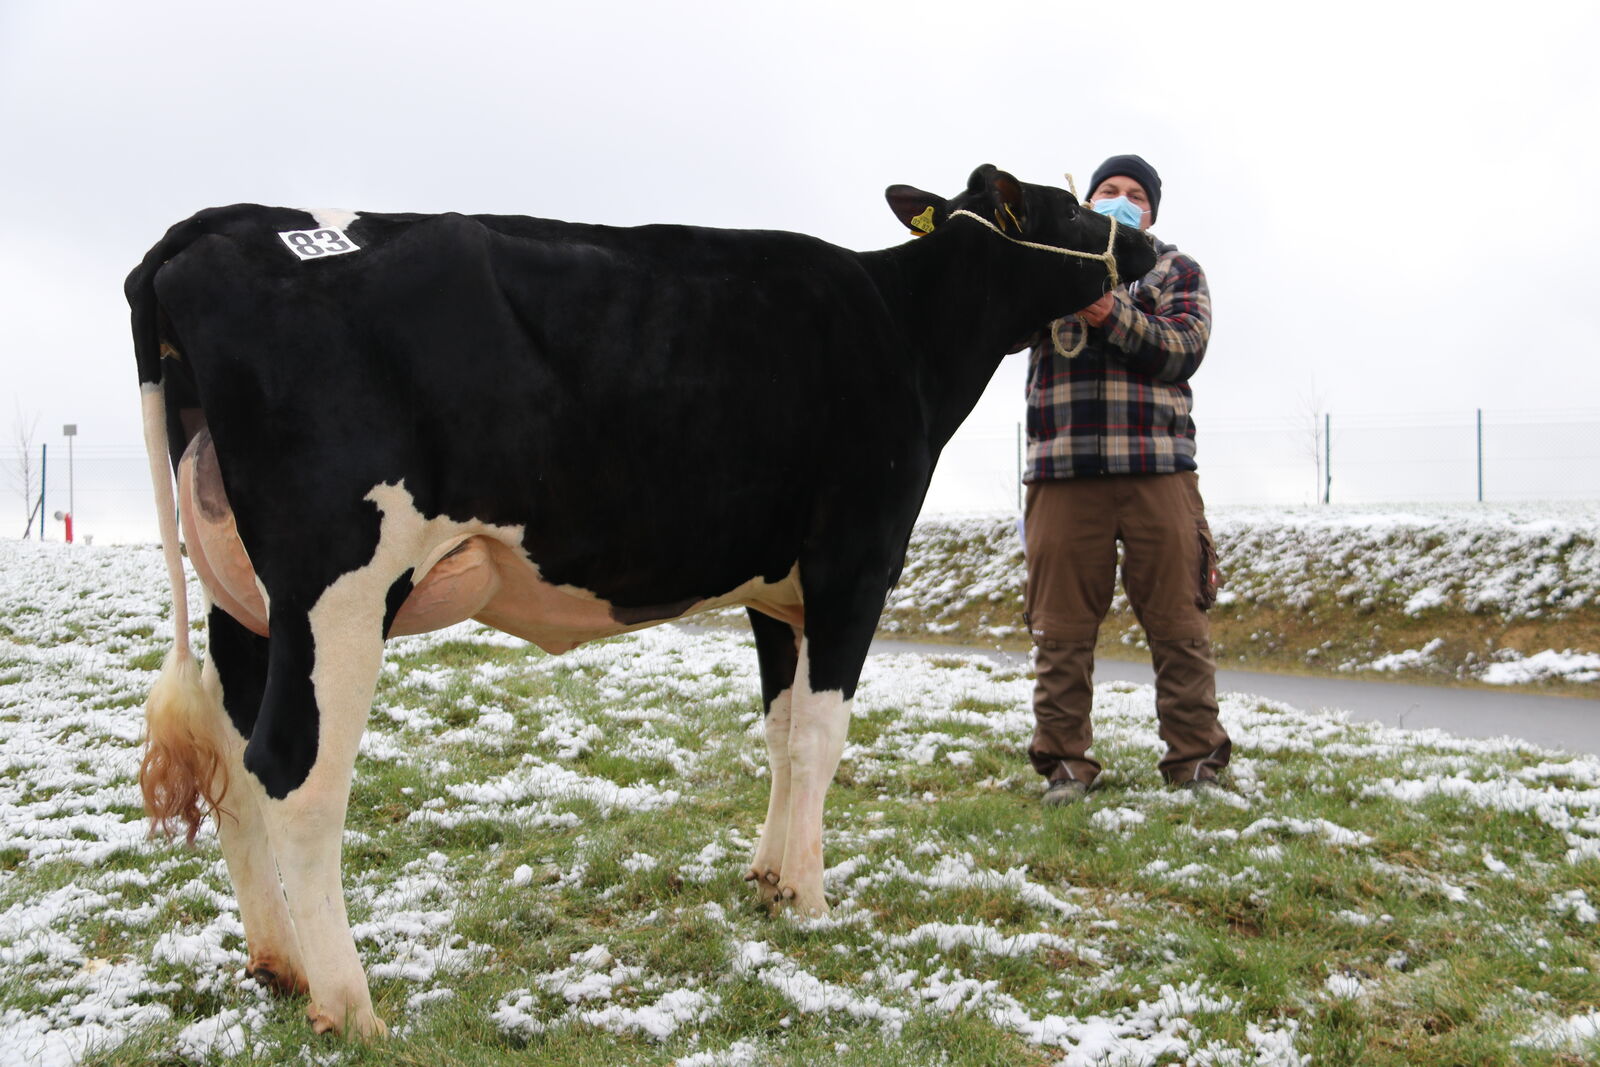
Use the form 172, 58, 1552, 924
1024, 472, 1232, 785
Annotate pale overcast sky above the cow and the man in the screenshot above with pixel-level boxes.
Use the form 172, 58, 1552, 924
0, 0, 1600, 531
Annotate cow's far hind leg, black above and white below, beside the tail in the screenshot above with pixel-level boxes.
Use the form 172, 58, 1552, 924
200, 606, 307, 993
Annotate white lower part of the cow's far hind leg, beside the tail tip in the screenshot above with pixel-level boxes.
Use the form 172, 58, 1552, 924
200, 657, 306, 993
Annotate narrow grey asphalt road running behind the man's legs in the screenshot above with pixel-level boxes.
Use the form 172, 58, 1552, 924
872, 640, 1600, 753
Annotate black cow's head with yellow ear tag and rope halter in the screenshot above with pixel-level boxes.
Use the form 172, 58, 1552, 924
885, 163, 1155, 303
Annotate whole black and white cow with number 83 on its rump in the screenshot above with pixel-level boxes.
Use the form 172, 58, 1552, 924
126, 166, 1155, 1035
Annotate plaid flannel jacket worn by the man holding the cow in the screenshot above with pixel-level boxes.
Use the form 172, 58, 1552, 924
1022, 242, 1211, 482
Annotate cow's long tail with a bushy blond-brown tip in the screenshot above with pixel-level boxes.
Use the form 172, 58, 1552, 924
128, 250, 227, 843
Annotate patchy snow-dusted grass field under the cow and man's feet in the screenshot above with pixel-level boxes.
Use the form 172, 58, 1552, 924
9, 544, 1600, 1067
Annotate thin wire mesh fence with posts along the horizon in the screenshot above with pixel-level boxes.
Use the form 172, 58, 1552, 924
9, 410, 1600, 541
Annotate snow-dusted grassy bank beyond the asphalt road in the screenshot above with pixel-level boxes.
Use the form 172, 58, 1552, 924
883, 504, 1600, 685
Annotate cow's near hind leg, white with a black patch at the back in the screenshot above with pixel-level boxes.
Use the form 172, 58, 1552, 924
245, 588, 386, 1038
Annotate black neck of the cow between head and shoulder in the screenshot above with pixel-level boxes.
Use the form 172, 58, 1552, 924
866, 226, 1072, 450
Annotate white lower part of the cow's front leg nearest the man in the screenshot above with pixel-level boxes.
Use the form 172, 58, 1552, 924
779, 641, 850, 915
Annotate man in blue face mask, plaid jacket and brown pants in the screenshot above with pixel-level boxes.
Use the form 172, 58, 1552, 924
1024, 155, 1232, 806
